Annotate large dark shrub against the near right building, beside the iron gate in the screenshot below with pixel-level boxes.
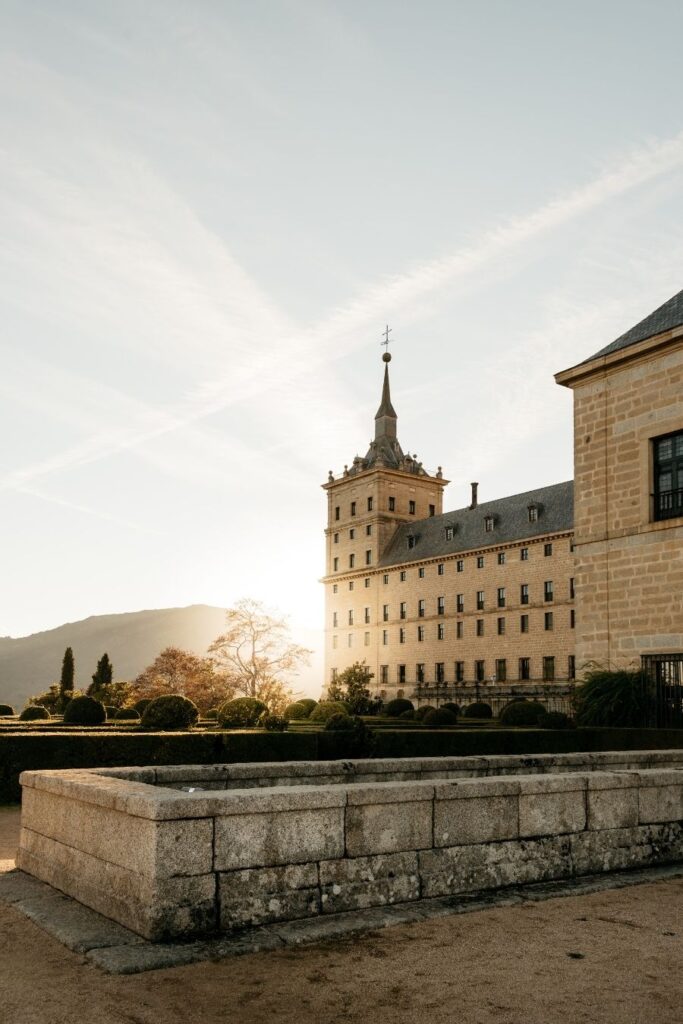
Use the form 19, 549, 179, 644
574, 669, 649, 727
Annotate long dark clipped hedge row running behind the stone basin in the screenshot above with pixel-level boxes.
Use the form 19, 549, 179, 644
0, 728, 683, 803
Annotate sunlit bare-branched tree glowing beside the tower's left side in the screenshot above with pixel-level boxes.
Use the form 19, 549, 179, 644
209, 598, 311, 712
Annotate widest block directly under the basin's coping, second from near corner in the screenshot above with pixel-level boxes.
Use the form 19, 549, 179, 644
214, 807, 344, 871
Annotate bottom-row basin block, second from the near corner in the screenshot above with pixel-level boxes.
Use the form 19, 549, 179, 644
218, 864, 321, 932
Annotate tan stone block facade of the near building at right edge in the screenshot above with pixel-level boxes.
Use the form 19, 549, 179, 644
556, 315, 683, 669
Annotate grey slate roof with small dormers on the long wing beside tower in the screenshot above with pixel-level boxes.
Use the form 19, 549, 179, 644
380, 480, 573, 566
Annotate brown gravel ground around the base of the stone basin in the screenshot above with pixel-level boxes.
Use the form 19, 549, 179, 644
0, 808, 683, 1024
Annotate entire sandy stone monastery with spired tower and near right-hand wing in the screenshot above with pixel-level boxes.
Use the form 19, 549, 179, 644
324, 291, 683, 710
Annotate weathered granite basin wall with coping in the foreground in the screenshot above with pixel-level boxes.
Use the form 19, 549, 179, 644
17, 751, 683, 940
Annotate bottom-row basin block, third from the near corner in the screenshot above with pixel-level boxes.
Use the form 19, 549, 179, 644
319, 853, 420, 913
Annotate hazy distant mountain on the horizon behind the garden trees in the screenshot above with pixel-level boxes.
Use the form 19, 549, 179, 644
0, 604, 323, 710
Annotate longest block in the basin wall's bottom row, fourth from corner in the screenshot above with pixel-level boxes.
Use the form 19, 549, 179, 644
418, 837, 571, 897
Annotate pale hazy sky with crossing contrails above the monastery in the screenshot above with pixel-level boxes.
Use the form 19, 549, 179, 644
0, 0, 683, 671
